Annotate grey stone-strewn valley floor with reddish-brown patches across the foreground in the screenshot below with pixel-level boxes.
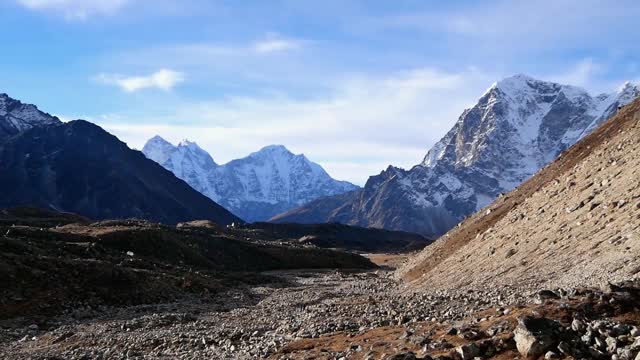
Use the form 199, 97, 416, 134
0, 255, 640, 360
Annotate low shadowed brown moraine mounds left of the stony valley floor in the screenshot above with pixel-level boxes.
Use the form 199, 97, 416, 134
0, 207, 375, 321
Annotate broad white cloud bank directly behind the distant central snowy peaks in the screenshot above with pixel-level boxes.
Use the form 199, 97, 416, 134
93, 68, 494, 184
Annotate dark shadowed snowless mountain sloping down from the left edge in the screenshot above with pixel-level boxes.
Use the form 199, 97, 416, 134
0, 120, 240, 224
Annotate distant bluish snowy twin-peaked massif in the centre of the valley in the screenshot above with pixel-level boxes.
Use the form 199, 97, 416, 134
142, 136, 358, 222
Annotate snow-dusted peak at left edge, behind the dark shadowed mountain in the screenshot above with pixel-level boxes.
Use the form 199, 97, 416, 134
0, 94, 61, 141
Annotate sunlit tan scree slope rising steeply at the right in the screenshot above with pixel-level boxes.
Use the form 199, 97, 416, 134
398, 100, 640, 289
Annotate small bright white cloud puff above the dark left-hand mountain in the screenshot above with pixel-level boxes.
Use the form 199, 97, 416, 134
95, 69, 184, 92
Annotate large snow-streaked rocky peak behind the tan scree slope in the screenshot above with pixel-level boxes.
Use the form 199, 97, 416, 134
272, 75, 640, 236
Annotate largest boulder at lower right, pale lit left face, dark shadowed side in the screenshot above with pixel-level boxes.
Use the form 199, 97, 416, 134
513, 316, 556, 358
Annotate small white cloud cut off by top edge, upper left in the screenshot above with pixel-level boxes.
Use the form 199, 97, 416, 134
17, 0, 130, 20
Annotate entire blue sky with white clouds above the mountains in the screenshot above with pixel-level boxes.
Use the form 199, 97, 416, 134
0, 0, 640, 184
